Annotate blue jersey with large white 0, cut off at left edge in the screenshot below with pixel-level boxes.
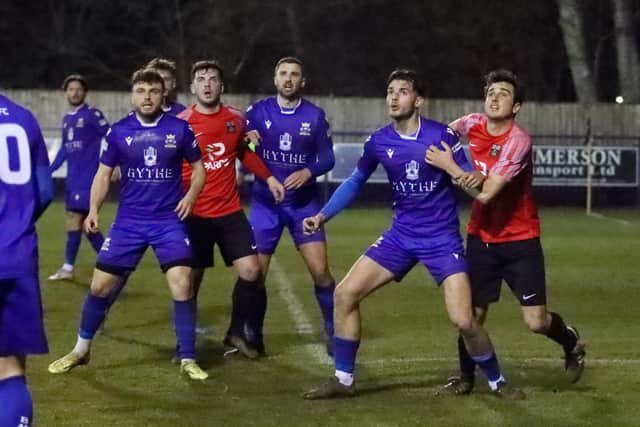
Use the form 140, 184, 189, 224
0, 95, 49, 279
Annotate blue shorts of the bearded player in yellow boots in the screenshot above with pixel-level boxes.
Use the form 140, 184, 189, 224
96, 220, 192, 276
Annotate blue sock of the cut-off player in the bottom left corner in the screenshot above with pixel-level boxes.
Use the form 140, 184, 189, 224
0, 376, 33, 427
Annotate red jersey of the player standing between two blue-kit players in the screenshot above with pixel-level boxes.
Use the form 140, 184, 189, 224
178, 105, 271, 218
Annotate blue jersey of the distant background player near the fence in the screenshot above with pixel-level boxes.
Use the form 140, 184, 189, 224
61, 104, 109, 192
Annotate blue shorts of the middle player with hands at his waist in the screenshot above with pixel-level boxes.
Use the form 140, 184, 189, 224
249, 200, 327, 254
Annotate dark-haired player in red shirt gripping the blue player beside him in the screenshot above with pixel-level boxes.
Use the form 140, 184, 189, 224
426, 70, 585, 395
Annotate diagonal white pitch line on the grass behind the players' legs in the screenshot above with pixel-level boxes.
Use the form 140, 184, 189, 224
271, 256, 330, 365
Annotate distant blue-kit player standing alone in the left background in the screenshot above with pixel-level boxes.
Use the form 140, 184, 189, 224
48, 74, 109, 280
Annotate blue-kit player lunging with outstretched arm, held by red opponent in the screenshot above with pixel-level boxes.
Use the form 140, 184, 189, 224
303, 70, 524, 399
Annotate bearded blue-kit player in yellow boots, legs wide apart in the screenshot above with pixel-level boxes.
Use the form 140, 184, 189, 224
49, 70, 208, 380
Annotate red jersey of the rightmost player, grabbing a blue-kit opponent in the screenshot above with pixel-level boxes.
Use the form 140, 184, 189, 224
452, 114, 540, 243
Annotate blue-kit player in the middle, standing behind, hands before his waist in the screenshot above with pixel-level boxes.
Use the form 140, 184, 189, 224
246, 57, 335, 354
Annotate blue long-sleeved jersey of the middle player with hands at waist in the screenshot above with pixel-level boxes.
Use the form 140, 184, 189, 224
246, 97, 335, 205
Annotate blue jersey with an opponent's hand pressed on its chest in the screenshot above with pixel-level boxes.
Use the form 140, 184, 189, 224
357, 117, 473, 236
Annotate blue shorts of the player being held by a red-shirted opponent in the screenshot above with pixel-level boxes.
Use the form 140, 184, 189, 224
364, 227, 468, 286
